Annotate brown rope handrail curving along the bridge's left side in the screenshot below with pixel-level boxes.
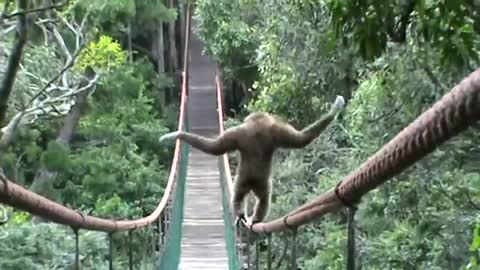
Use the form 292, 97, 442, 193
0, 2, 191, 233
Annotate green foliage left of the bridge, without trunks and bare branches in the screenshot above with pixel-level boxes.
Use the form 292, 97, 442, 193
0, 0, 182, 270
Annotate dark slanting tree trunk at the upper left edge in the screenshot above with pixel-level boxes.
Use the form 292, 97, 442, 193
0, 0, 27, 125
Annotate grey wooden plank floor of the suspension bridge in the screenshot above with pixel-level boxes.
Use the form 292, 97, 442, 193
179, 24, 228, 270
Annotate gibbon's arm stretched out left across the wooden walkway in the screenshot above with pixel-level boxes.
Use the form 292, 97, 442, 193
159, 126, 243, 155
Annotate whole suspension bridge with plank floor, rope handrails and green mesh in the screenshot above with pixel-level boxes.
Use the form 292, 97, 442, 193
0, 2, 480, 270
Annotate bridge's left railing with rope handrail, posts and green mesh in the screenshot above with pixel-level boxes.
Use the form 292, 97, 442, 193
0, 2, 191, 269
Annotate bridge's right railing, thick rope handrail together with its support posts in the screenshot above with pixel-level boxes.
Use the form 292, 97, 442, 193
217, 65, 480, 270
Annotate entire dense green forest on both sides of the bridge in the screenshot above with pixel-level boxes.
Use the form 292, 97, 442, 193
0, 0, 480, 270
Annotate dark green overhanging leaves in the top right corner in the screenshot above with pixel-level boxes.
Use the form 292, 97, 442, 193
327, 0, 480, 66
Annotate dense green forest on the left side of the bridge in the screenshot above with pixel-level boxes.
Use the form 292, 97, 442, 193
0, 0, 185, 270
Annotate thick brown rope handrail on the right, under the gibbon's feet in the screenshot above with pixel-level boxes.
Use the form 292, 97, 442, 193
217, 68, 480, 233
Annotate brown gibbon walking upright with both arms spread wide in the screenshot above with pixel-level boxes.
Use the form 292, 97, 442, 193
160, 96, 344, 224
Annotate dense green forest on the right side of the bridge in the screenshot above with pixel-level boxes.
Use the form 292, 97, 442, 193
195, 0, 480, 270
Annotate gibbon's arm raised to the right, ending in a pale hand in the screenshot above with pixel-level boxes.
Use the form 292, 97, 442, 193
273, 96, 345, 148
